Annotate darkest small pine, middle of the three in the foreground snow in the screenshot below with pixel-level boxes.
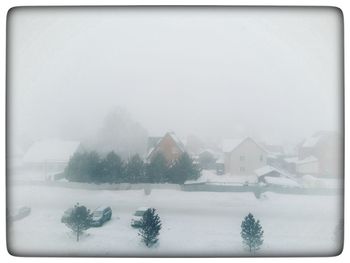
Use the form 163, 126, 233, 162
138, 208, 162, 247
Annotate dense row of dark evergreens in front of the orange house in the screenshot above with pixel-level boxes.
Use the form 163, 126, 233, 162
64, 151, 201, 184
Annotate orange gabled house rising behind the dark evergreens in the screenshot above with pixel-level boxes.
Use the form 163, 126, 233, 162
146, 132, 185, 164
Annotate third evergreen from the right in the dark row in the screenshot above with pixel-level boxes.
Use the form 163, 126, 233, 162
126, 154, 146, 183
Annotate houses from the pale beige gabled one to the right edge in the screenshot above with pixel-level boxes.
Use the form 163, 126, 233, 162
218, 132, 342, 177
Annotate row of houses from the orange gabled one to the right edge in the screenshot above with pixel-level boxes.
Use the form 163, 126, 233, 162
146, 132, 342, 184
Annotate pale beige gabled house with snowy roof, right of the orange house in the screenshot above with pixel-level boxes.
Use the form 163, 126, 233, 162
223, 137, 268, 175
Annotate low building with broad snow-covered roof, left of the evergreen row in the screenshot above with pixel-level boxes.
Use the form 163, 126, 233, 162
23, 140, 81, 178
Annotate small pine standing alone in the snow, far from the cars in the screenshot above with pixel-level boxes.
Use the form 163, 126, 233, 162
241, 213, 264, 253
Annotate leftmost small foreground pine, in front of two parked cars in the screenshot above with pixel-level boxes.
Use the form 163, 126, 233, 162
64, 203, 92, 242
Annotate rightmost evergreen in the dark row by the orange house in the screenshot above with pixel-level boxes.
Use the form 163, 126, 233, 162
168, 153, 201, 184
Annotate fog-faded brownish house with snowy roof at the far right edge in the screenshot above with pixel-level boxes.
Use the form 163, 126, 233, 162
298, 131, 343, 177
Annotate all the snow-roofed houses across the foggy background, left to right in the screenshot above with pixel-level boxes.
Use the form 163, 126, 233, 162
11, 132, 342, 182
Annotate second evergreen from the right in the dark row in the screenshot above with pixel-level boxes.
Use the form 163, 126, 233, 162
146, 153, 168, 183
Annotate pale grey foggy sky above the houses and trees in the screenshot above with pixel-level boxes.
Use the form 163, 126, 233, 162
8, 8, 342, 147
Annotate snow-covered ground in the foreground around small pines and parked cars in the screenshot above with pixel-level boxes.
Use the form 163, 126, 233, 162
8, 185, 342, 256
